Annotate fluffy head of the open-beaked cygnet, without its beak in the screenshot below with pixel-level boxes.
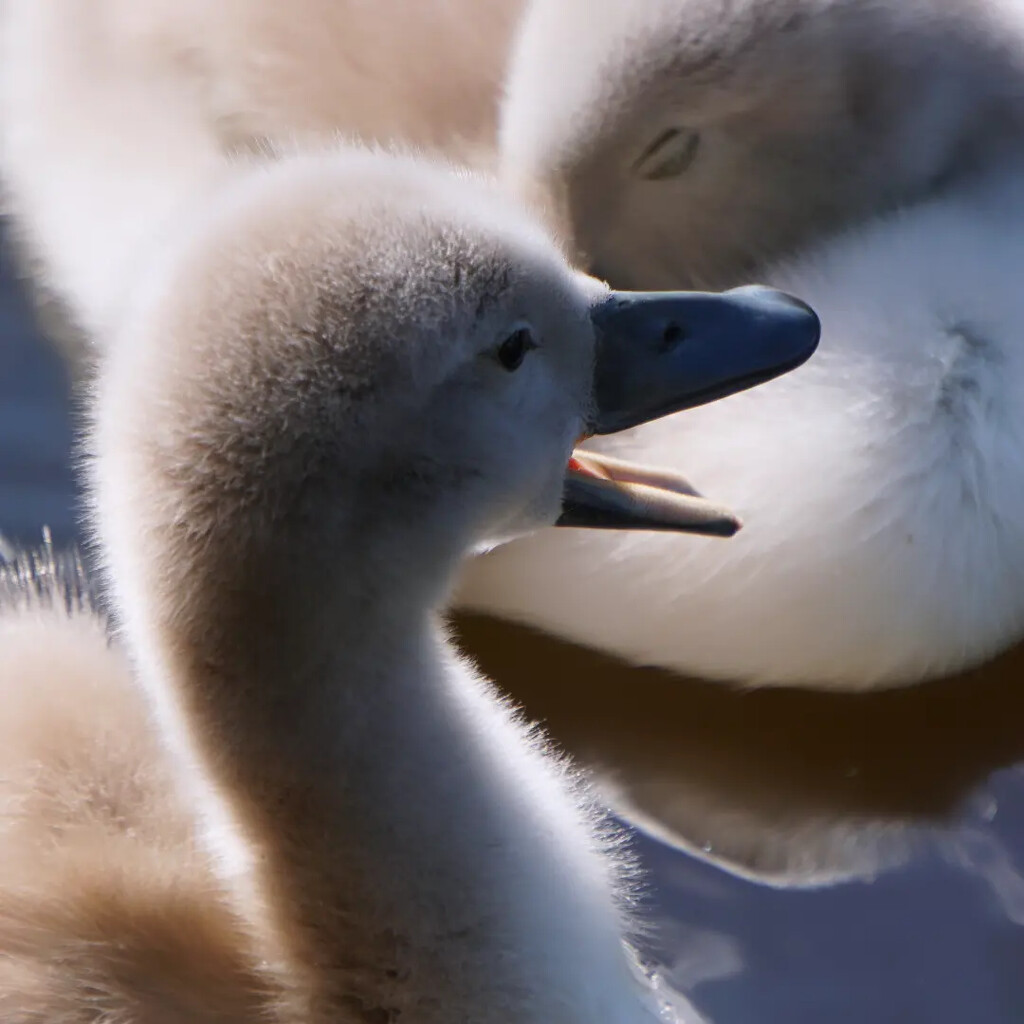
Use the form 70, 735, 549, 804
98, 155, 585, 602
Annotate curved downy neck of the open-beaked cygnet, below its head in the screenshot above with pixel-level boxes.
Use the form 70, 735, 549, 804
113, 485, 650, 1024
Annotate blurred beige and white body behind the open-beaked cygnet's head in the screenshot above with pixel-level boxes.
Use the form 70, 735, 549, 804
0, 0, 520, 360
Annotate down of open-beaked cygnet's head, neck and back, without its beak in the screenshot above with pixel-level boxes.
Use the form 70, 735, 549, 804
0, 134, 671, 1024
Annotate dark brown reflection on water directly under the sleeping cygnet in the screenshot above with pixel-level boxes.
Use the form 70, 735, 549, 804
459, 615, 1024, 884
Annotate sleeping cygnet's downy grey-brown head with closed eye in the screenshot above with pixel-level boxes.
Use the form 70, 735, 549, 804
501, 0, 1022, 288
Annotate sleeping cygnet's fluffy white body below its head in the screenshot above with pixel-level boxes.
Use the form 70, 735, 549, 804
463, 169, 1024, 689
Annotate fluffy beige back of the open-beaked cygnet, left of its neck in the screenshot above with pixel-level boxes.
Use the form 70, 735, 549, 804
0, 547, 272, 1024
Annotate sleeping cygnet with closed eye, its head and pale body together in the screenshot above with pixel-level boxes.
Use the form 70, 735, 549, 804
462, 0, 1024, 689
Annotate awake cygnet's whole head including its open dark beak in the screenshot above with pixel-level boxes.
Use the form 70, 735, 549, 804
96, 146, 817, 622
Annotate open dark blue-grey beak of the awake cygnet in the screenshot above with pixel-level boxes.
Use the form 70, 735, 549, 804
558, 286, 821, 537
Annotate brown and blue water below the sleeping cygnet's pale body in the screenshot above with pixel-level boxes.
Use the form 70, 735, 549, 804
458, 616, 1024, 1024
